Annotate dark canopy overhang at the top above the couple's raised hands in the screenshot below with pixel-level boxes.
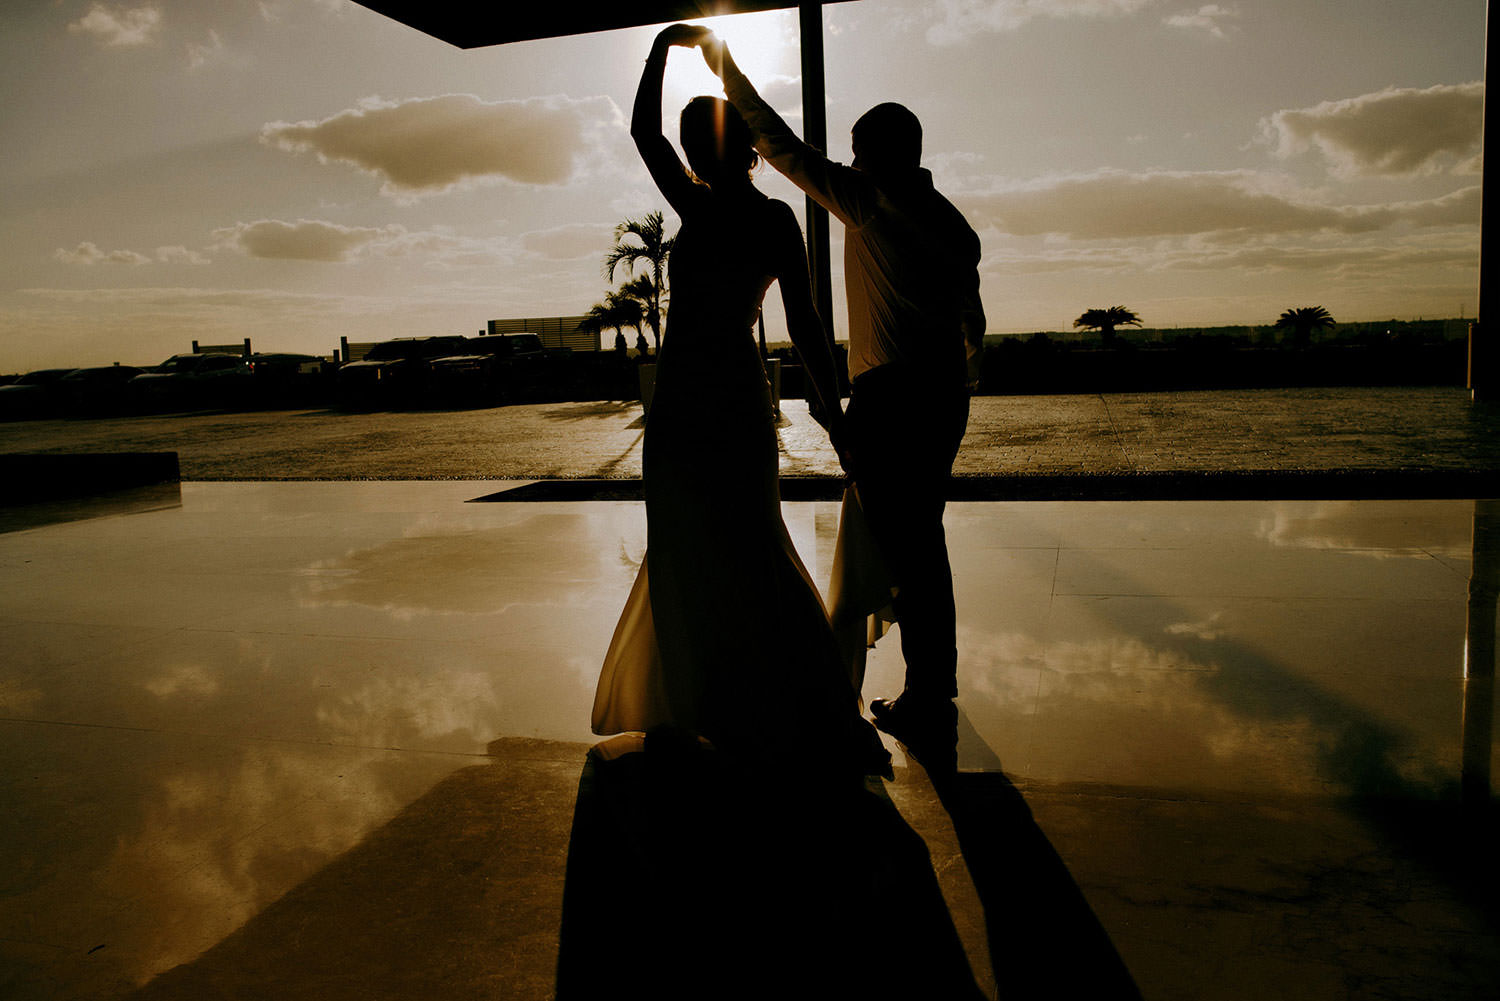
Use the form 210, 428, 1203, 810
345, 0, 842, 48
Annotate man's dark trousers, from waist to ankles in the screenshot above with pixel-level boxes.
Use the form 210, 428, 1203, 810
848, 365, 969, 699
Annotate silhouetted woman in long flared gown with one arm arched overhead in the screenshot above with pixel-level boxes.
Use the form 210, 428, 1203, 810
593, 24, 890, 777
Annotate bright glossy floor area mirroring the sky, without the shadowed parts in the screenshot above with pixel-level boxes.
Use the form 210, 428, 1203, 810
0, 482, 1496, 998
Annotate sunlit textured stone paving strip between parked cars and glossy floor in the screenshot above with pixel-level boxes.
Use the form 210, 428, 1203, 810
0, 387, 1500, 480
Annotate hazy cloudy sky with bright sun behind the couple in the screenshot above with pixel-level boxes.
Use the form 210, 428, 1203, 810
0, 0, 1485, 372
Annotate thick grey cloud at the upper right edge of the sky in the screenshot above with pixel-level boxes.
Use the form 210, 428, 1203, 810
1260, 81, 1485, 176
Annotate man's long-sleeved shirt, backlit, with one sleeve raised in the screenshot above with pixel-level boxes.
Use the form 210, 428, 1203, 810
723, 63, 984, 386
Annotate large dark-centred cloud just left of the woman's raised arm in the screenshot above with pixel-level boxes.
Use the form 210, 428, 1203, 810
261, 95, 621, 198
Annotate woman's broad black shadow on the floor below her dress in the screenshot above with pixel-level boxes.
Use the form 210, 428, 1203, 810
557, 732, 984, 1001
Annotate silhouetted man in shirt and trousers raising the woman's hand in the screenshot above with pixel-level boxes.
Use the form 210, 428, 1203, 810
699, 30, 984, 758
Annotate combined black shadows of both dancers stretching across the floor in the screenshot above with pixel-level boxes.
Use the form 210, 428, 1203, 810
557, 717, 1140, 1001
